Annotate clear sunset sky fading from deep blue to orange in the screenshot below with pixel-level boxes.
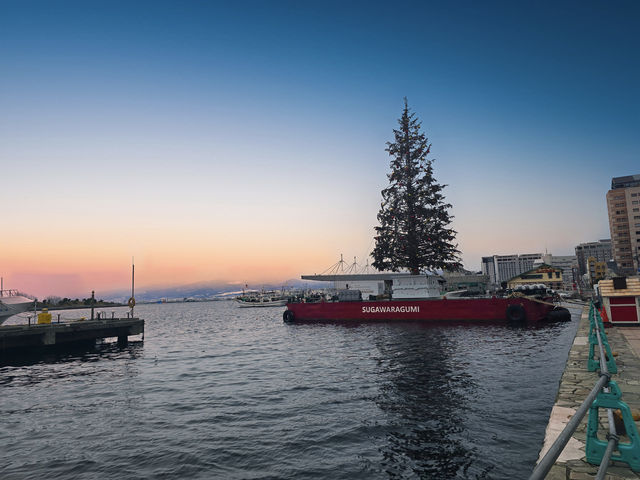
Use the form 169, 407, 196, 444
0, 0, 640, 297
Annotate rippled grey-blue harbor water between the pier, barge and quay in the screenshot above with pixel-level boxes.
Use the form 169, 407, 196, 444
0, 302, 579, 480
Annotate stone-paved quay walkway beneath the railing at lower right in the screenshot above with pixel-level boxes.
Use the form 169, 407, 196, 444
540, 307, 640, 480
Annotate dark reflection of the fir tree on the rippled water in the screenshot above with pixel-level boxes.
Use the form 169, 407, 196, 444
376, 327, 474, 478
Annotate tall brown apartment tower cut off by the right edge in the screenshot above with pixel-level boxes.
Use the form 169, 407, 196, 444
607, 175, 640, 275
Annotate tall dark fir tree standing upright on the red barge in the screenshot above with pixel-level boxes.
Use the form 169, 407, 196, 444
371, 98, 460, 274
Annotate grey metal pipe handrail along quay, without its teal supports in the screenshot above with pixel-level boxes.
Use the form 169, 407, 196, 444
529, 302, 618, 480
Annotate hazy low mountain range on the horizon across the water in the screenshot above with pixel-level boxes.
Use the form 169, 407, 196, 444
100, 279, 325, 302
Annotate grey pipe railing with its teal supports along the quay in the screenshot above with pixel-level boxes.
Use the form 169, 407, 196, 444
529, 302, 640, 480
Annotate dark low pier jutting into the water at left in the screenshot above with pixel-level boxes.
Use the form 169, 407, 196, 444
0, 318, 144, 354
